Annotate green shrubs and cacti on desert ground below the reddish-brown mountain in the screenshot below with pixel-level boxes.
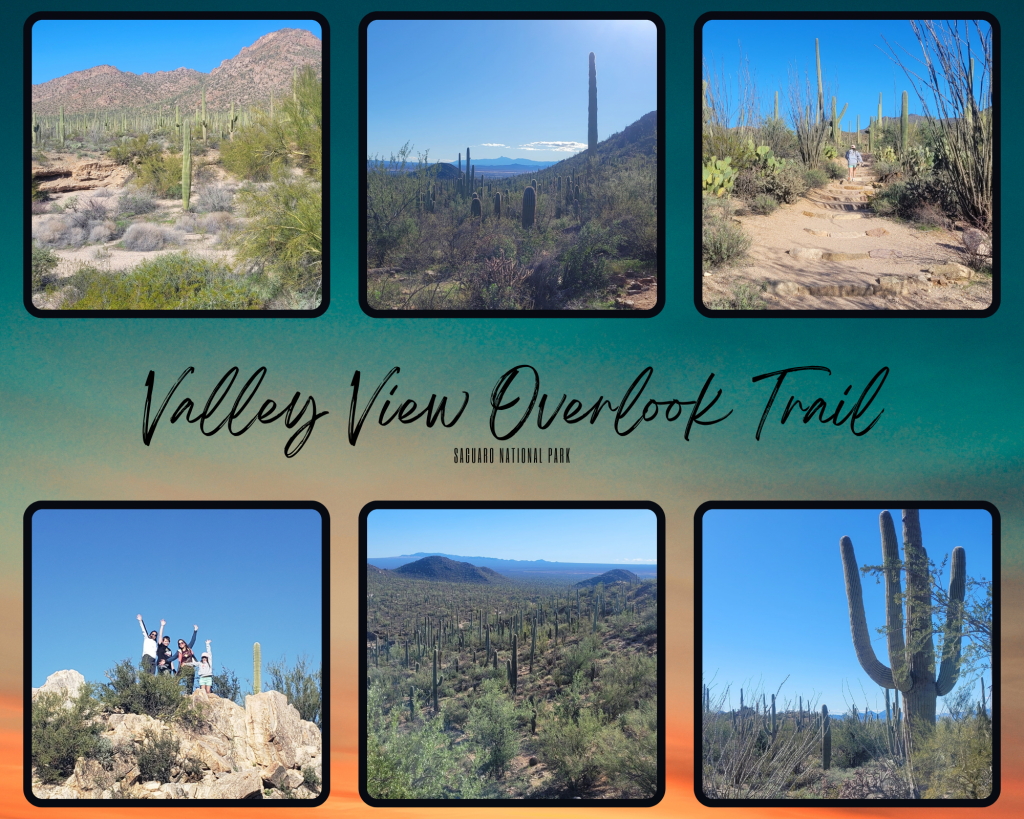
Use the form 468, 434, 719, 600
32, 67, 323, 310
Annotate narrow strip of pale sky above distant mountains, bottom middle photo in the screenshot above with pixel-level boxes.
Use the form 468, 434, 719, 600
367, 509, 657, 564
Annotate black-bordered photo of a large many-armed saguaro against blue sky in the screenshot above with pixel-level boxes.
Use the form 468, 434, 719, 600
693, 501, 1000, 808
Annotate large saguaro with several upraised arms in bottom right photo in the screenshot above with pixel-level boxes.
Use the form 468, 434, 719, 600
840, 509, 967, 749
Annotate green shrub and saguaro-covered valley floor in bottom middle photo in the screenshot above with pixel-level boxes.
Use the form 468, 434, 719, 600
366, 570, 659, 800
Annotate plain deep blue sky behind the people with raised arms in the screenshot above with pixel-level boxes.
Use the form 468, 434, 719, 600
32, 510, 323, 692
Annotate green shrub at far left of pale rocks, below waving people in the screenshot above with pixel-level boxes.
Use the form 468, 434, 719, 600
32, 687, 101, 783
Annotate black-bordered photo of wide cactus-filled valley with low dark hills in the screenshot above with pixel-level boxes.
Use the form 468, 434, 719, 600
356, 501, 666, 808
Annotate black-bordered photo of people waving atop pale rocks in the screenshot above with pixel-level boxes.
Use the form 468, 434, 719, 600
24, 501, 331, 808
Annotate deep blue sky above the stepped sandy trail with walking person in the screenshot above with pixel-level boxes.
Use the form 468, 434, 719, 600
701, 19, 988, 130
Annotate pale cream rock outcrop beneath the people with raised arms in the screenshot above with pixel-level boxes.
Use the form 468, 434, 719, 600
32, 671, 324, 800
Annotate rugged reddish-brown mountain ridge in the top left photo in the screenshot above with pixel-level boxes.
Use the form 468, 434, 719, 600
32, 24, 323, 115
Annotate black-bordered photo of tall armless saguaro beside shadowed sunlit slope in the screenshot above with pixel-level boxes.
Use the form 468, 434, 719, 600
359, 11, 666, 318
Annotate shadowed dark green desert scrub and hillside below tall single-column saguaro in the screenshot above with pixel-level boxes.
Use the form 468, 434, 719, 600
366, 110, 658, 310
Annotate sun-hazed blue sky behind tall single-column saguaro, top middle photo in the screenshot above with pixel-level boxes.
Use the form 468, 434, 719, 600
367, 20, 657, 163
